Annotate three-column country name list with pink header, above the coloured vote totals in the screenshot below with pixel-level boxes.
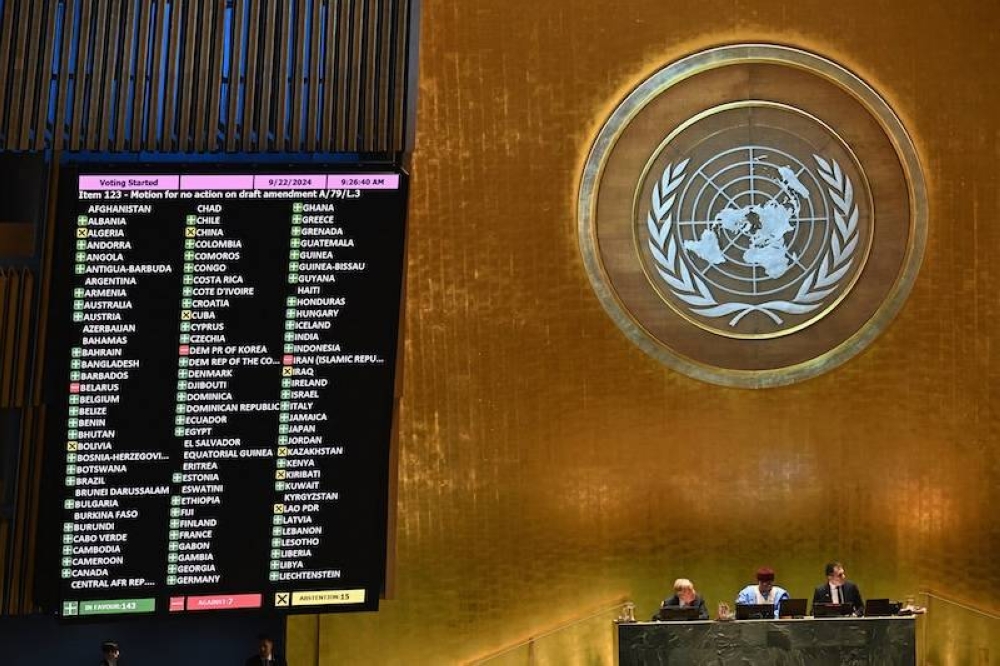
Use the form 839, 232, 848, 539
62, 174, 399, 608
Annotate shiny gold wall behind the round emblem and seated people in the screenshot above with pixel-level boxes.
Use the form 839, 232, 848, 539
289, 0, 1000, 666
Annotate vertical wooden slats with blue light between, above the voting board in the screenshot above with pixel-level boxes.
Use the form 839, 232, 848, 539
0, 0, 413, 154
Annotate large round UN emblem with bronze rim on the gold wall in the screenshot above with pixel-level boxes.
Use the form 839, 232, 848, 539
580, 45, 926, 387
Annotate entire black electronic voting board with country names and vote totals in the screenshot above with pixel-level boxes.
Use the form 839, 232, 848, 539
38, 164, 407, 618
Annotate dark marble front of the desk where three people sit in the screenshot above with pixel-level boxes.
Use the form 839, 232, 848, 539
616, 616, 917, 666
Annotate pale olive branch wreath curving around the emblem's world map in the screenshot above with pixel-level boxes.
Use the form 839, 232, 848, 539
646, 155, 859, 326
